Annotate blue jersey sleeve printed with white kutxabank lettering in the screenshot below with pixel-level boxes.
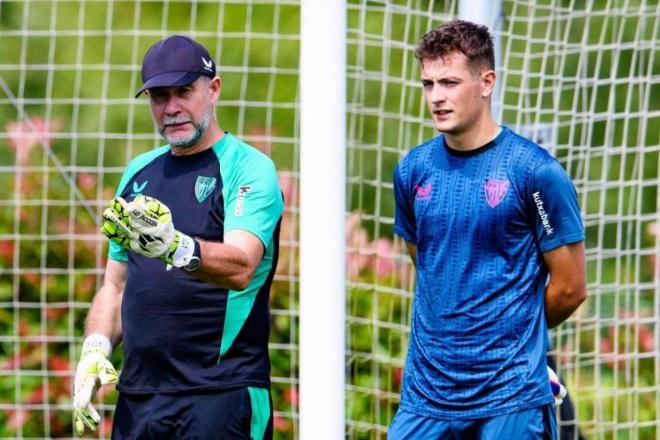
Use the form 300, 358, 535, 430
528, 159, 584, 252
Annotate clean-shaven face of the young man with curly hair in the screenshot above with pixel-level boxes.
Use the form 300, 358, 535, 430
421, 52, 494, 135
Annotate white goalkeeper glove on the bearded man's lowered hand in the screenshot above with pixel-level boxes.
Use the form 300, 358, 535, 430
73, 333, 117, 435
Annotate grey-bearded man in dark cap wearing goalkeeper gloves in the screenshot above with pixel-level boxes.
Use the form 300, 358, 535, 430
74, 36, 283, 439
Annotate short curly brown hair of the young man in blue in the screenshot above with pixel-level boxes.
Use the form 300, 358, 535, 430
415, 20, 495, 69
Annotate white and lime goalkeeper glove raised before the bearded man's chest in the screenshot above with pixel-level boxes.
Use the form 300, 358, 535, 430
101, 195, 195, 268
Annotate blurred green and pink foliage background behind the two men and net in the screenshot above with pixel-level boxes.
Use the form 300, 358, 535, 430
0, 0, 660, 438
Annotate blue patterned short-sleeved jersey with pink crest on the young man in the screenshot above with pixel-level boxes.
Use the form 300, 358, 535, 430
394, 127, 584, 419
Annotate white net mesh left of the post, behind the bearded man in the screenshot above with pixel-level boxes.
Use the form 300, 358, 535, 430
0, 0, 299, 438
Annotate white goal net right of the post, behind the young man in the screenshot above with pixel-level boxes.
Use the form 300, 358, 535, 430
347, 0, 660, 438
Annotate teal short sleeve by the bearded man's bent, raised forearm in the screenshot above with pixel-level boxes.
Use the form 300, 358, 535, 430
221, 147, 284, 248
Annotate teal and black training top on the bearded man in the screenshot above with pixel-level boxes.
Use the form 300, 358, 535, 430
109, 133, 284, 394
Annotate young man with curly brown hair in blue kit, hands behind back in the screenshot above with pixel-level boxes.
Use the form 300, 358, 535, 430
389, 21, 586, 440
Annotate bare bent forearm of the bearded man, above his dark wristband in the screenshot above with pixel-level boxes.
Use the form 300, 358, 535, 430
191, 240, 254, 290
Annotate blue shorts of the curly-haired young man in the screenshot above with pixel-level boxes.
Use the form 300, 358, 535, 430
387, 405, 557, 440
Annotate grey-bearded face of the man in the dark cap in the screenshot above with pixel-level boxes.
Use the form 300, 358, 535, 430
149, 78, 217, 148
